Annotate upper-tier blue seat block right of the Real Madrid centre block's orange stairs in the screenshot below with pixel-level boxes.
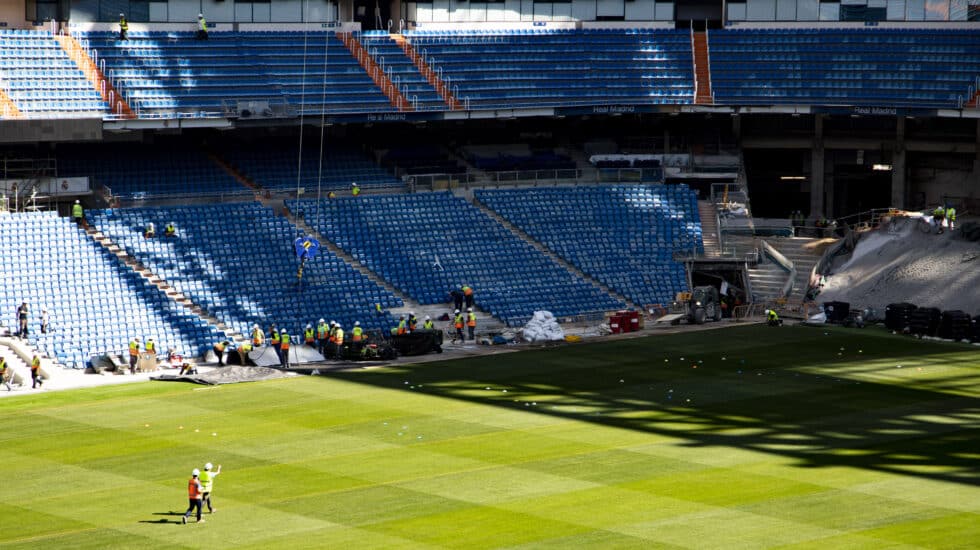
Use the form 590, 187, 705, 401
708, 29, 980, 108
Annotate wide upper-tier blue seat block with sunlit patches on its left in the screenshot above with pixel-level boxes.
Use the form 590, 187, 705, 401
80, 31, 393, 116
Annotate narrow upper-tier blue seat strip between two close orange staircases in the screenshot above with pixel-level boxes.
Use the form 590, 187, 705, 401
354, 31, 446, 111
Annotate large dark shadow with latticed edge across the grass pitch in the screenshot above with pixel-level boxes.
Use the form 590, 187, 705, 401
327, 326, 980, 485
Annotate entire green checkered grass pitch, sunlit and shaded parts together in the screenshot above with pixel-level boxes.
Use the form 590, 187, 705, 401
0, 326, 980, 549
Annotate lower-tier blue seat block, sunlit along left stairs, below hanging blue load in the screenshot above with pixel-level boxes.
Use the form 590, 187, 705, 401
86, 203, 402, 335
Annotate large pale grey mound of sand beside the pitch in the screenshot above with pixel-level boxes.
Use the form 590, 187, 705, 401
817, 220, 980, 316
